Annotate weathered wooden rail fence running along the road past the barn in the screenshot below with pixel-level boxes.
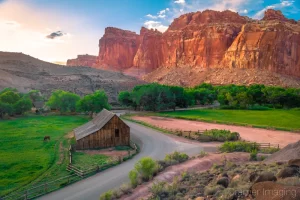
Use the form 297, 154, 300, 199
0, 141, 138, 200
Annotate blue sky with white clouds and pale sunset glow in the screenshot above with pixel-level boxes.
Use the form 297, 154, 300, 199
0, 0, 300, 62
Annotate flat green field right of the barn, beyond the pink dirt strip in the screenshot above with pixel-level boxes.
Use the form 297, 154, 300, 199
158, 109, 300, 131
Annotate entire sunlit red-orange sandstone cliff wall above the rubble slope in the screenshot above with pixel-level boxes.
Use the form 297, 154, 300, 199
97, 10, 300, 84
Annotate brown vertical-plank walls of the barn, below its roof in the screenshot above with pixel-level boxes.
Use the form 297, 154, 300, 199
76, 116, 130, 149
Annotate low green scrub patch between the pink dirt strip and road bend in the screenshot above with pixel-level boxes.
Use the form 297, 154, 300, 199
203, 129, 240, 142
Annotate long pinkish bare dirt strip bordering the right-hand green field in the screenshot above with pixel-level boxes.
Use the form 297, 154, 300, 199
133, 116, 300, 148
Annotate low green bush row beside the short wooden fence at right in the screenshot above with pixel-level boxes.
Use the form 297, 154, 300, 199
220, 141, 259, 153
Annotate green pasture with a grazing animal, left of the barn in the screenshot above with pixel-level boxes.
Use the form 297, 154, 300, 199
0, 116, 89, 196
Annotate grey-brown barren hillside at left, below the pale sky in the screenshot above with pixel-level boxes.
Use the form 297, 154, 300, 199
0, 52, 141, 102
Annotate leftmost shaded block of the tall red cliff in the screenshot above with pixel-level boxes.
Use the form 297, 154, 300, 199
97, 27, 140, 70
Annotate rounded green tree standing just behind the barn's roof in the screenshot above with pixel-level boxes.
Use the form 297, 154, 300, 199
77, 90, 111, 116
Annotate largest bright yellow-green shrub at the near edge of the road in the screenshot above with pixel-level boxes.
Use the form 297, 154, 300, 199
134, 157, 159, 181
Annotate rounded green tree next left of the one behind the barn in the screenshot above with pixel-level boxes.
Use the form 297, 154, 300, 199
46, 90, 80, 112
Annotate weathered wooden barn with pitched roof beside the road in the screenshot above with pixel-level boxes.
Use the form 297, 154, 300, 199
74, 109, 130, 150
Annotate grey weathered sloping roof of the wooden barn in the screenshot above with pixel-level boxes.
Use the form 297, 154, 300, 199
74, 108, 115, 140
